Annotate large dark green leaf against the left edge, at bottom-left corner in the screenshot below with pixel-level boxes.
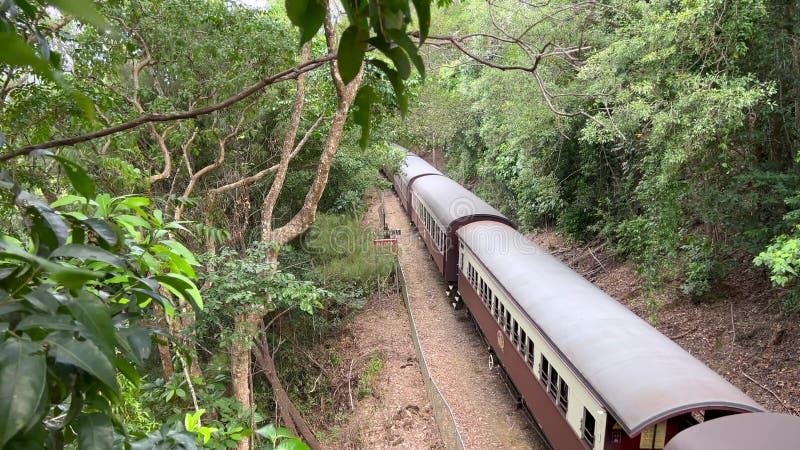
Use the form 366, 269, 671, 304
0, 339, 47, 448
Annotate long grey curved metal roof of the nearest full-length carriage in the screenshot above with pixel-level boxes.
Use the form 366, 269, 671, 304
458, 222, 763, 436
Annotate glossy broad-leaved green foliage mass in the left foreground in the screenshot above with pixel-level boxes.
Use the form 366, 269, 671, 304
0, 155, 202, 448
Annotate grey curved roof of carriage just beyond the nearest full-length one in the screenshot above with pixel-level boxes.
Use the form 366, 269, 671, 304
414, 176, 510, 228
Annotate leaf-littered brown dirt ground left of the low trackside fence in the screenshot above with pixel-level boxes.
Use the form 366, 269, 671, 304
325, 199, 444, 449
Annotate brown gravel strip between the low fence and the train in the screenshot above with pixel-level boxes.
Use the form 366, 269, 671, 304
385, 194, 548, 450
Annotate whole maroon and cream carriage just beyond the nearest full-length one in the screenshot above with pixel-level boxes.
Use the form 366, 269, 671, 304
411, 176, 513, 295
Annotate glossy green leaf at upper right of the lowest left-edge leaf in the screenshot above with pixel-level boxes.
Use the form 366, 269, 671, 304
45, 332, 119, 395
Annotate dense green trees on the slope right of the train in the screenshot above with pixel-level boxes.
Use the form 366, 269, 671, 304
406, 0, 800, 306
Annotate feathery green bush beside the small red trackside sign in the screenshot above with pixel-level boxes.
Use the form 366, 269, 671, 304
306, 215, 395, 288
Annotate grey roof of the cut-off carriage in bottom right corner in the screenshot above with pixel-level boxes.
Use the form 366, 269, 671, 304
665, 413, 800, 450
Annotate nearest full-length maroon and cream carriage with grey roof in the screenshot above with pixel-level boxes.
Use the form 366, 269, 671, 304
454, 222, 762, 450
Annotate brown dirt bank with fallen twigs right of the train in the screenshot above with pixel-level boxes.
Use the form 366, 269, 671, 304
529, 230, 800, 415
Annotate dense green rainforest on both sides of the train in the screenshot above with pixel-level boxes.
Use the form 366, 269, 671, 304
0, 0, 800, 449
